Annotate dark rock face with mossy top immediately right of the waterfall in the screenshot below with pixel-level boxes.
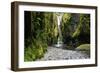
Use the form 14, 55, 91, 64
61, 13, 80, 47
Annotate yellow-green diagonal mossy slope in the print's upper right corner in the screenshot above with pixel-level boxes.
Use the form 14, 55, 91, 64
72, 14, 90, 38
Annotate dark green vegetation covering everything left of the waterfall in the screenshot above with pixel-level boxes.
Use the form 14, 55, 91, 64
24, 11, 58, 61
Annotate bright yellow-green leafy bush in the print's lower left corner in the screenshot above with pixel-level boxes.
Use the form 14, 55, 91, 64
25, 40, 47, 61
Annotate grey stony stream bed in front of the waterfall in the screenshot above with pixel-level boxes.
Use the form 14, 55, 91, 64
38, 47, 89, 61
